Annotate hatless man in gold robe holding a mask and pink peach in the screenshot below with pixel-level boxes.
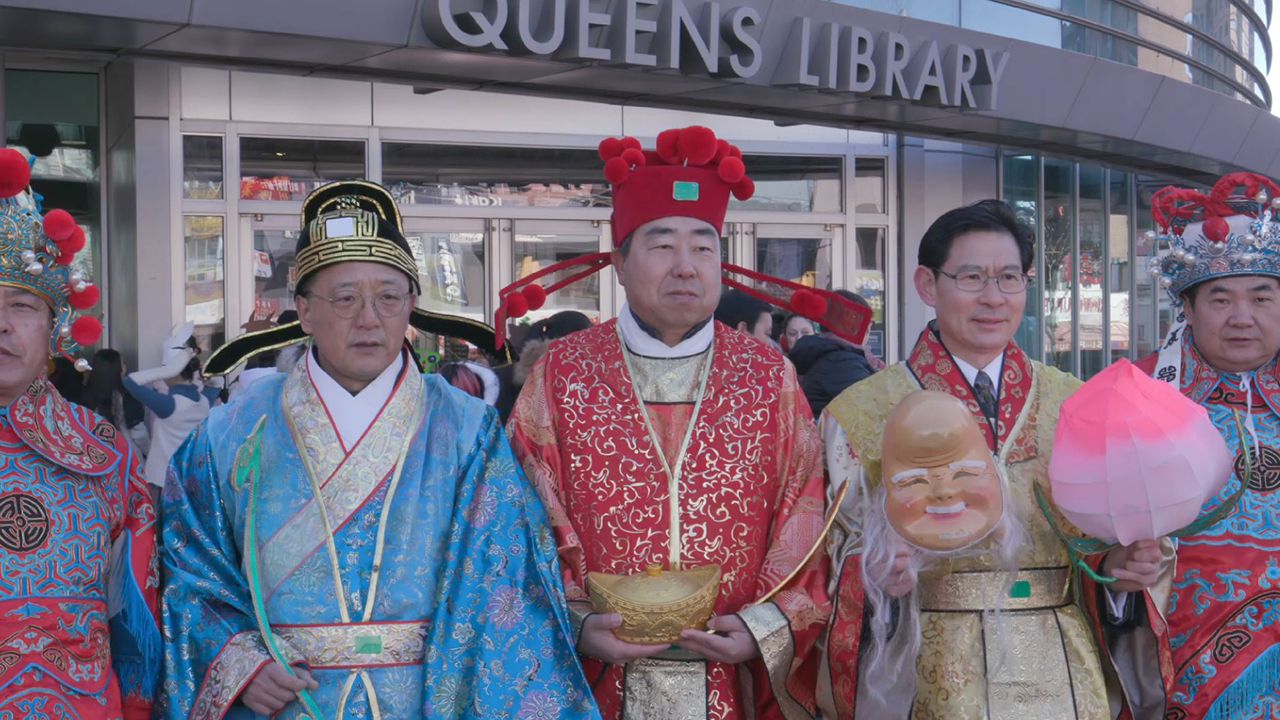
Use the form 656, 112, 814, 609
818, 200, 1169, 720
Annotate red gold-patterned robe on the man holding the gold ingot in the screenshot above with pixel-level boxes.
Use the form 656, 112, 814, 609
508, 322, 828, 719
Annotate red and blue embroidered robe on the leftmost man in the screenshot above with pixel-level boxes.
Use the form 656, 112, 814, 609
0, 378, 163, 720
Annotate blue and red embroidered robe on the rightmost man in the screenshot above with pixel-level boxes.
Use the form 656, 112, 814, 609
1139, 329, 1280, 720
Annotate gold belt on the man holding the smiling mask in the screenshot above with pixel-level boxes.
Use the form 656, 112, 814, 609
919, 568, 1071, 612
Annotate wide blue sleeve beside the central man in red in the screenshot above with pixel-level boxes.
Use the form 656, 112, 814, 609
424, 409, 600, 720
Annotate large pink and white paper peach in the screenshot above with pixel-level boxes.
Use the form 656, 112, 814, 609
1048, 360, 1233, 544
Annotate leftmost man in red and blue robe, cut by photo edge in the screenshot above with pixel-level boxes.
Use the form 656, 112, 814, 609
0, 149, 163, 720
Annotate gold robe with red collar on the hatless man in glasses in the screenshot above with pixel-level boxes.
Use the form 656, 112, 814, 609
819, 328, 1160, 720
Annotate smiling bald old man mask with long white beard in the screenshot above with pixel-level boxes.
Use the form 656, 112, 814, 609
883, 391, 1005, 552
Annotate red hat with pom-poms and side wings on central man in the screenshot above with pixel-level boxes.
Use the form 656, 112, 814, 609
494, 126, 872, 347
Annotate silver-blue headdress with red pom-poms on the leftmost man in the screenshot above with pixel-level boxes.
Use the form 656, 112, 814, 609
0, 149, 102, 370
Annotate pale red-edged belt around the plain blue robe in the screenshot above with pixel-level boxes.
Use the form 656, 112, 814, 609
271, 621, 428, 669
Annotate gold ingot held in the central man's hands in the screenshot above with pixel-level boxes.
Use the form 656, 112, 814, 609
586, 565, 721, 644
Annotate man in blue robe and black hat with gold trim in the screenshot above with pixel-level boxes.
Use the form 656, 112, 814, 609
163, 182, 598, 720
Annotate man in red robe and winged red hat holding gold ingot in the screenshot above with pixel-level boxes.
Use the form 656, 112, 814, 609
498, 128, 856, 719
